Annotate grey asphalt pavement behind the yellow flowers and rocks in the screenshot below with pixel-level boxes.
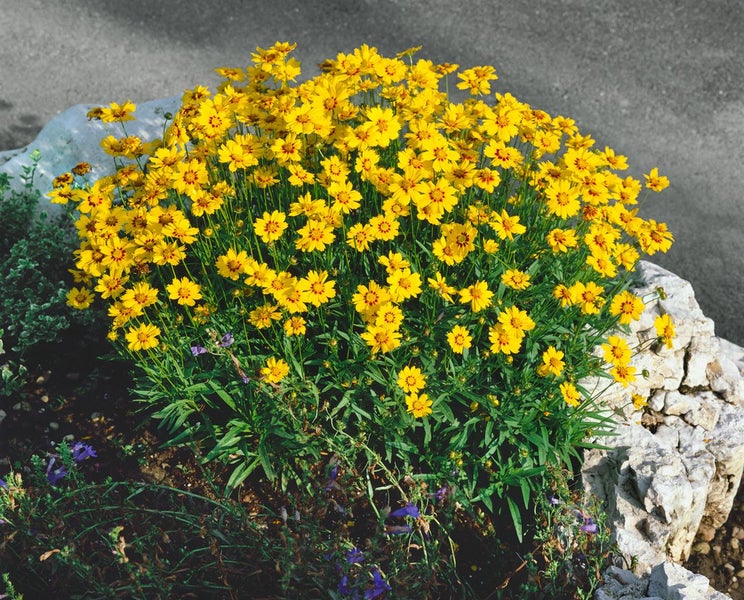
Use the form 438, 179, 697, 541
0, 0, 744, 345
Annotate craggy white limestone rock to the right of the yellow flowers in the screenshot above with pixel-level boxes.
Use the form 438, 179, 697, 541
582, 262, 744, 600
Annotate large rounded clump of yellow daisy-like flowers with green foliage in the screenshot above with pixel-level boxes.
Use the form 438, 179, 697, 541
56, 43, 673, 515
